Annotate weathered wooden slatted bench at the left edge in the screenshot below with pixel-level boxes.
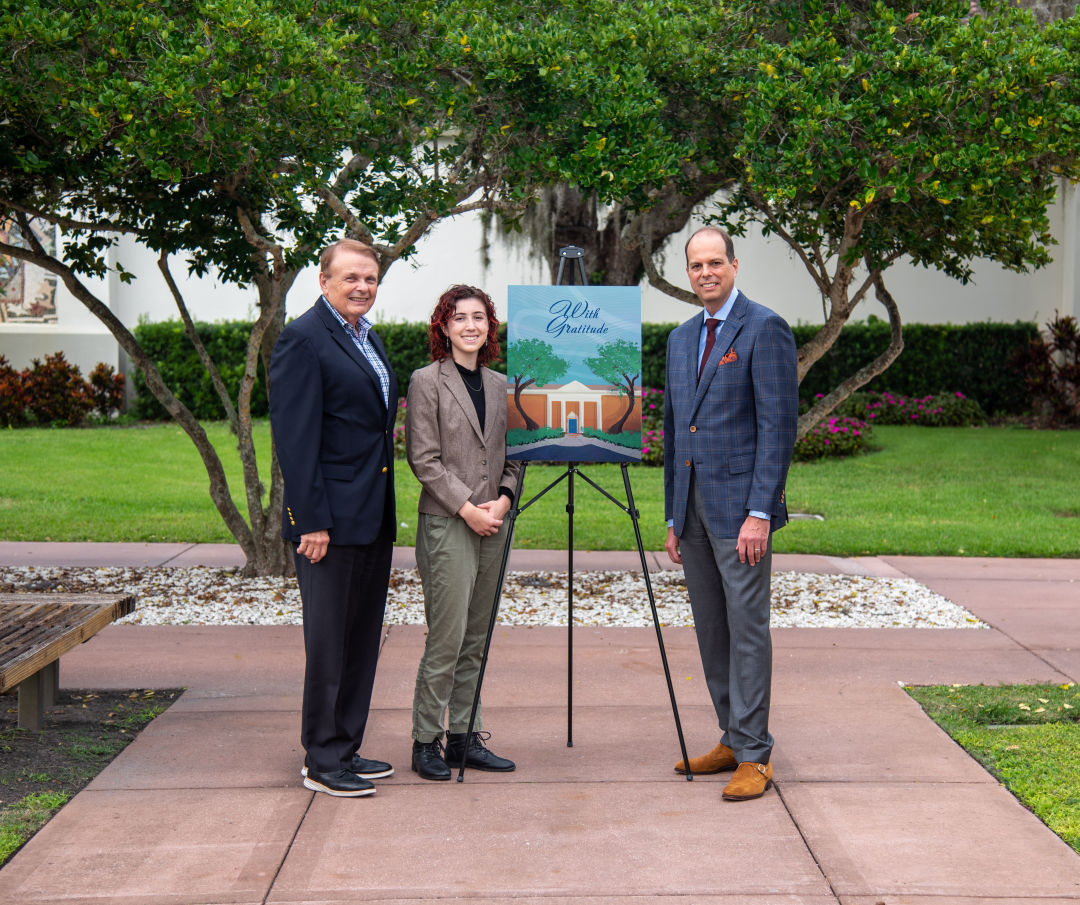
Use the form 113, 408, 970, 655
0, 594, 135, 729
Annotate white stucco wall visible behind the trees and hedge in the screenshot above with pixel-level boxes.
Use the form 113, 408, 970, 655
0, 180, 1080, 373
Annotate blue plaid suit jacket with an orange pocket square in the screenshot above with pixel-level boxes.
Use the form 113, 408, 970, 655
664, 293, 799, 538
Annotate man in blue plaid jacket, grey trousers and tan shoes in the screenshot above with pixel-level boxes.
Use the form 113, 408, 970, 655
664, 227, 798, 801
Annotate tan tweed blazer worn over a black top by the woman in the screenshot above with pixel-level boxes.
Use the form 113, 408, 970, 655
405, 359, 521, 516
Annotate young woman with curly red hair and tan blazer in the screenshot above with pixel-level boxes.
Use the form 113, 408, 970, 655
405, 285, 519, 780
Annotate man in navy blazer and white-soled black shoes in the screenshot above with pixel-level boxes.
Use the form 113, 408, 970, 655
270, 239, 397, 797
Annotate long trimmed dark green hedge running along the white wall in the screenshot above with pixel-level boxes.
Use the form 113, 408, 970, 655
135, 320, 1039, 418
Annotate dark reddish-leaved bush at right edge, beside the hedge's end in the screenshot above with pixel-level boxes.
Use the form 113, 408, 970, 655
1013, 315, 1080, 424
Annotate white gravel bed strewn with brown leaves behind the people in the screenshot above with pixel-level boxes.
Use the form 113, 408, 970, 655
0, 566, 987, 629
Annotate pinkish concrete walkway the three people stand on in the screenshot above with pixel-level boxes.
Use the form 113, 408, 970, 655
0, 543, 1080, 905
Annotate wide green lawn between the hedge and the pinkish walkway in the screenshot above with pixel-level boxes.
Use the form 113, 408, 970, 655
0, 422, 1080, 556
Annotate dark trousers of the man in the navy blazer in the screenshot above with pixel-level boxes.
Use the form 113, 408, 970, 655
293, 528, 393, 773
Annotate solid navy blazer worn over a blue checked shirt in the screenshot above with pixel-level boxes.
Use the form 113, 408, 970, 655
269, 298, 397, 544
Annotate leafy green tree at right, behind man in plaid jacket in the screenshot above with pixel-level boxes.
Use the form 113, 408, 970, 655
643, 0, 1080, 434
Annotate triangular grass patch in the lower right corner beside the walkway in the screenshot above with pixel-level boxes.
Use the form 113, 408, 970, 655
907, 683, 1080, 852
